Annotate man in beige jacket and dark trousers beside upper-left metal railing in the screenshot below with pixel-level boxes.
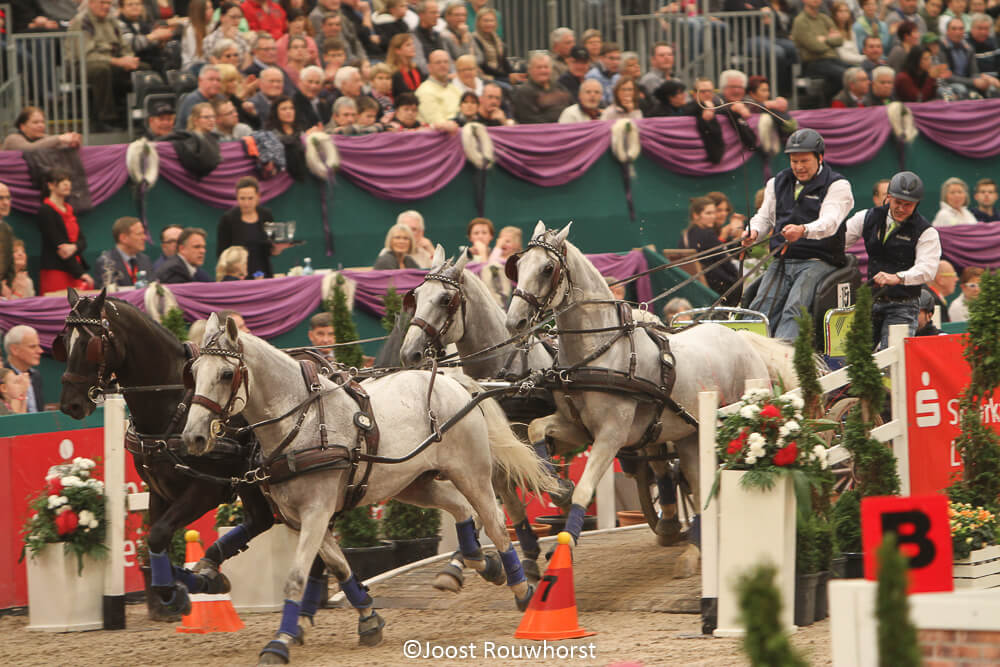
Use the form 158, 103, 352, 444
67, 0, 141, 132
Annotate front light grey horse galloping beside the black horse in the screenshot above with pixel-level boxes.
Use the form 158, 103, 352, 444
183, 314, 551, 664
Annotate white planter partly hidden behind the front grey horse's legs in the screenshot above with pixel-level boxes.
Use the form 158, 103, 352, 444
219, 524, 299, 613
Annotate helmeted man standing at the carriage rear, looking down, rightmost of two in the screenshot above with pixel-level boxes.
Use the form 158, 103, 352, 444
844, 171, 941, 349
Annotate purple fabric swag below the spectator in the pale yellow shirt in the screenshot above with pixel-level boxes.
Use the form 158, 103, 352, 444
335, 132, 465, 201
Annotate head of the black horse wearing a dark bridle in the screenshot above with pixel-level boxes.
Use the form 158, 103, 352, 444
58, 288, 125, 419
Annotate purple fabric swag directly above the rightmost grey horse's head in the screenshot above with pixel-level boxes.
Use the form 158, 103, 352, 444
490, 121, 611, 186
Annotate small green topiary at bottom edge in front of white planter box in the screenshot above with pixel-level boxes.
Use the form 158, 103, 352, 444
737, 565, 808, 667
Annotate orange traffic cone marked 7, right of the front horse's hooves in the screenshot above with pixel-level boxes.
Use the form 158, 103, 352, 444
514, 531, 596, 639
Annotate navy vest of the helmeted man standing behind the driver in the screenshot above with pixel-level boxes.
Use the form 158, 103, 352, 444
861, 204, 931, 299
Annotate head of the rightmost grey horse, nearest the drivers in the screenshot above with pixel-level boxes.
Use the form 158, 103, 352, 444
506, 220, 573, 333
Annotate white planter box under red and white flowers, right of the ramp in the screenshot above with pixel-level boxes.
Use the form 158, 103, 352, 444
715, 470, 795, 637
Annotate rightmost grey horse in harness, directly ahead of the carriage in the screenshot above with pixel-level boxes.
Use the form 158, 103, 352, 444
507, 222, 798, 568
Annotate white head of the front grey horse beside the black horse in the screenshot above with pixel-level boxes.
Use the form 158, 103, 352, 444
183, 313, 250, 456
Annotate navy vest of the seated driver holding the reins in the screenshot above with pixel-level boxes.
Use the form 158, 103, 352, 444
771, 164, 847, 266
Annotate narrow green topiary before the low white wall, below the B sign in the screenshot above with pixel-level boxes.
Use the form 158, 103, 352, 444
875, 533, 922, 667
